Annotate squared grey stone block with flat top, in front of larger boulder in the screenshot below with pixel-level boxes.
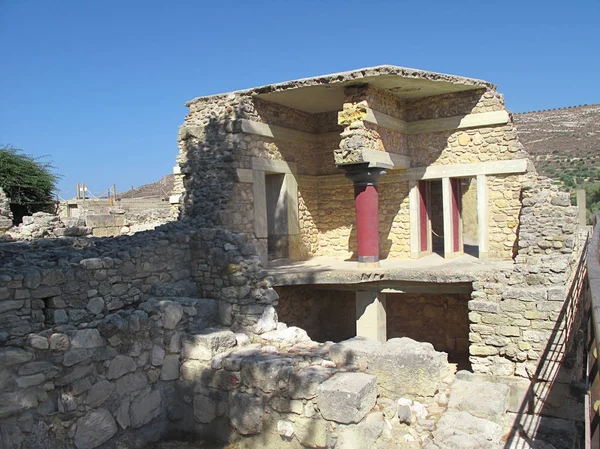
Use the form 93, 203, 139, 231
317, 373, 377, 424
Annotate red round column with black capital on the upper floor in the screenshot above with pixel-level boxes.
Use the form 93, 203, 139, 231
341, 164, 385, 263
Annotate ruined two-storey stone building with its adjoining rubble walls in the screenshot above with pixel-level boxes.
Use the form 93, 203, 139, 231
0, 66, 589, 449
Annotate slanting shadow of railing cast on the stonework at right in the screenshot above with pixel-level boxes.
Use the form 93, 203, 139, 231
504, 236, 591, 449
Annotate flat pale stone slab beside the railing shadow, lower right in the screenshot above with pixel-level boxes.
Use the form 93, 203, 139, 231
448, 380, 510, 424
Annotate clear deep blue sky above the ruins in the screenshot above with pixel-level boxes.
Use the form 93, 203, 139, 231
0, 0, 600, 197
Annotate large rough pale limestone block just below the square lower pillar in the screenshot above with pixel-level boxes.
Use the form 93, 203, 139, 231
368, 338, 447, 396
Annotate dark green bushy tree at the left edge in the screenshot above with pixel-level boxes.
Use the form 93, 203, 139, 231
0, 145, 59, 222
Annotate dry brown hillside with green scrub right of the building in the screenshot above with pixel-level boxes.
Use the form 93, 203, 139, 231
513, 104, 600, 187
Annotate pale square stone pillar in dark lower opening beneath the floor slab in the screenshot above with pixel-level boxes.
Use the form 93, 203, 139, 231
356, 291, 387, 343
